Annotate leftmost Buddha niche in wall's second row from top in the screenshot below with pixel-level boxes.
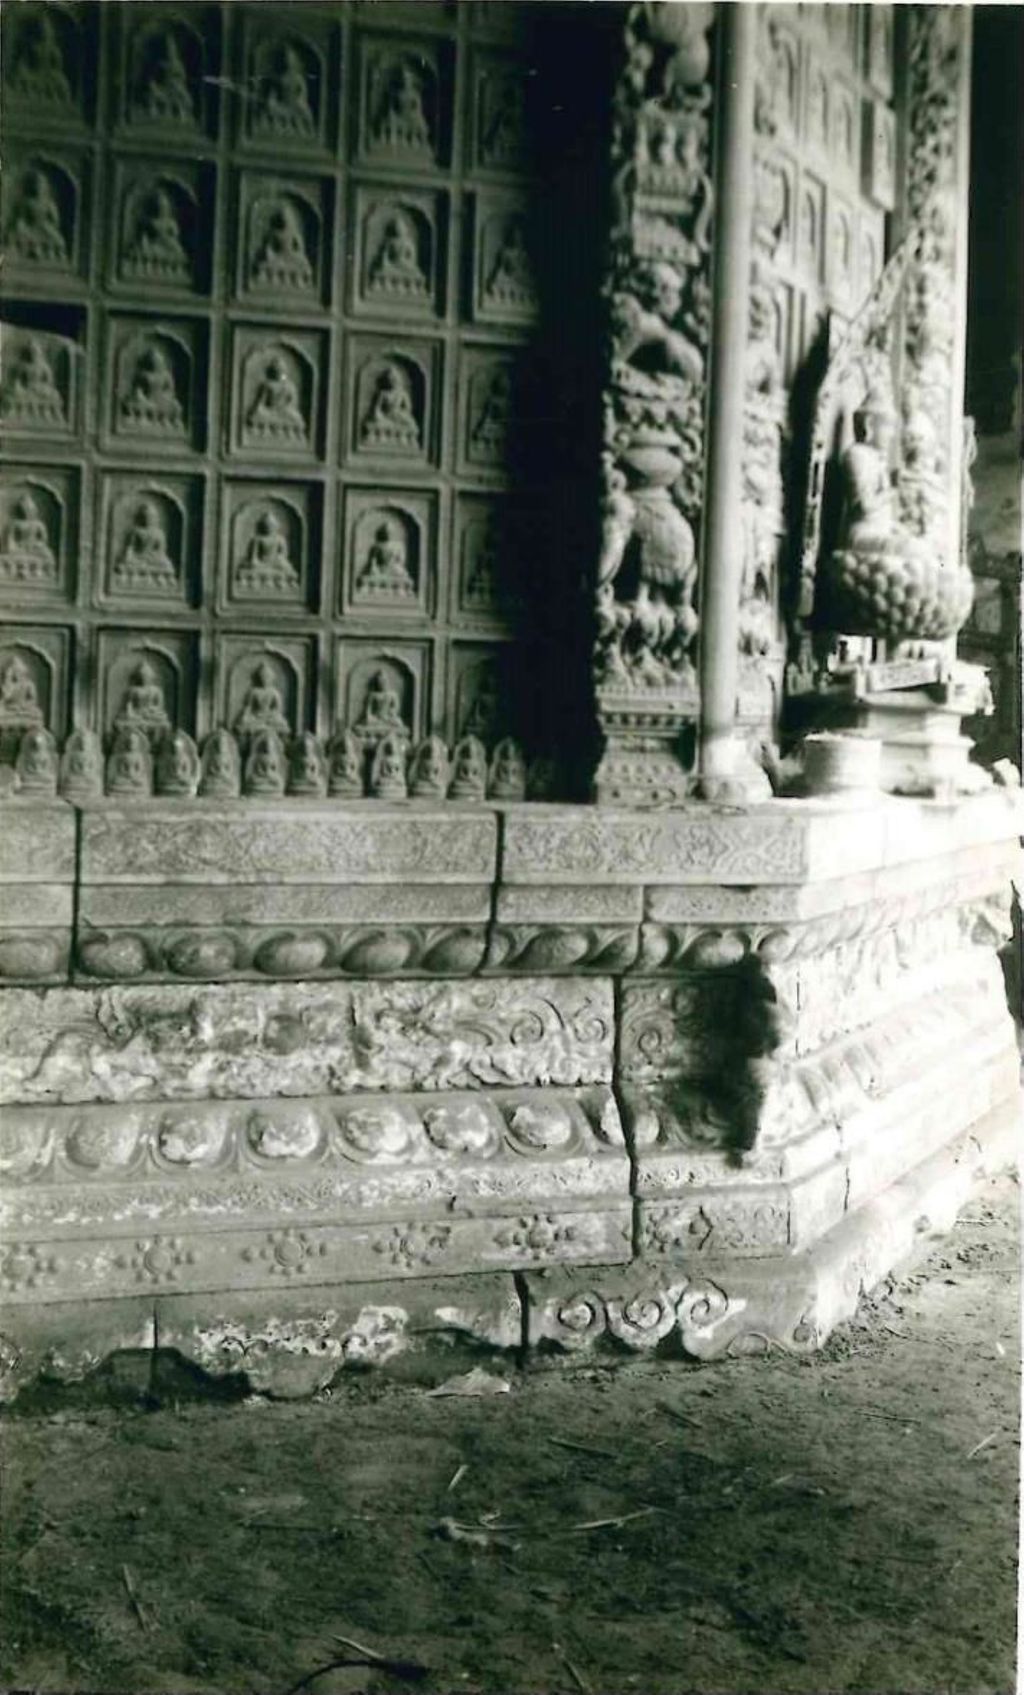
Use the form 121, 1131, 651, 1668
3, 146, 88, 290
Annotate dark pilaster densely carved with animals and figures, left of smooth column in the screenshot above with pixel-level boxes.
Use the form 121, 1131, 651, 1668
593, 5, 714, 803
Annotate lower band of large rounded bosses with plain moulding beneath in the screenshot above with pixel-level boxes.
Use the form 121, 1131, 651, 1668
0, 1086, 629, 1237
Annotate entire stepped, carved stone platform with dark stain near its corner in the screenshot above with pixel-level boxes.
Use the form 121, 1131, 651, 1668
0, 790, 1024, 1397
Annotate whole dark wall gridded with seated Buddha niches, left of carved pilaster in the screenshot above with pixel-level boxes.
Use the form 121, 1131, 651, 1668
0, 3, 573, 769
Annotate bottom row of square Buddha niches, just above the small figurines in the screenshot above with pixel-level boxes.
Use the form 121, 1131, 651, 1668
0, 624, 528, 763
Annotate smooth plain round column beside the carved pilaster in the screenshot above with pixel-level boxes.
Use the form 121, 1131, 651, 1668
700, 5, 770, 800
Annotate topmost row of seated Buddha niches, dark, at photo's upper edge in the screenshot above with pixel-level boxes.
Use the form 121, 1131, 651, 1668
3, 3, 532, 175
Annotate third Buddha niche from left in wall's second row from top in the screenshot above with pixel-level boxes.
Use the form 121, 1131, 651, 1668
237, 171, 331, 312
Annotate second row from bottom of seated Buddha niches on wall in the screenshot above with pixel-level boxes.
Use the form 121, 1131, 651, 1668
0, 466, 541, 625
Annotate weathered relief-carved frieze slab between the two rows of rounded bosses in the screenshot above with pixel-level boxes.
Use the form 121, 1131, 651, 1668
0, 978, 614, 1103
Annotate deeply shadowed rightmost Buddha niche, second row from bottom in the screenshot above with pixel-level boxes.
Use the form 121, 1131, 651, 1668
453, 495, 531, 622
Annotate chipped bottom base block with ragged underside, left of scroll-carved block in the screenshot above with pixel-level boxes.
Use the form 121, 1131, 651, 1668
156, 1275, 522, 1398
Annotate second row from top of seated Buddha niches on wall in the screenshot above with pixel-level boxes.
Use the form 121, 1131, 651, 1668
0, 162, 537, 324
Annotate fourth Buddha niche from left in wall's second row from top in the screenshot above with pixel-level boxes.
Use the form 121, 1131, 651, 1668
349, 183, 448, 320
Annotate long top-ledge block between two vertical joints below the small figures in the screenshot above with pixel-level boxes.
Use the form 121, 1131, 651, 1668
81, 802, 497, 883
